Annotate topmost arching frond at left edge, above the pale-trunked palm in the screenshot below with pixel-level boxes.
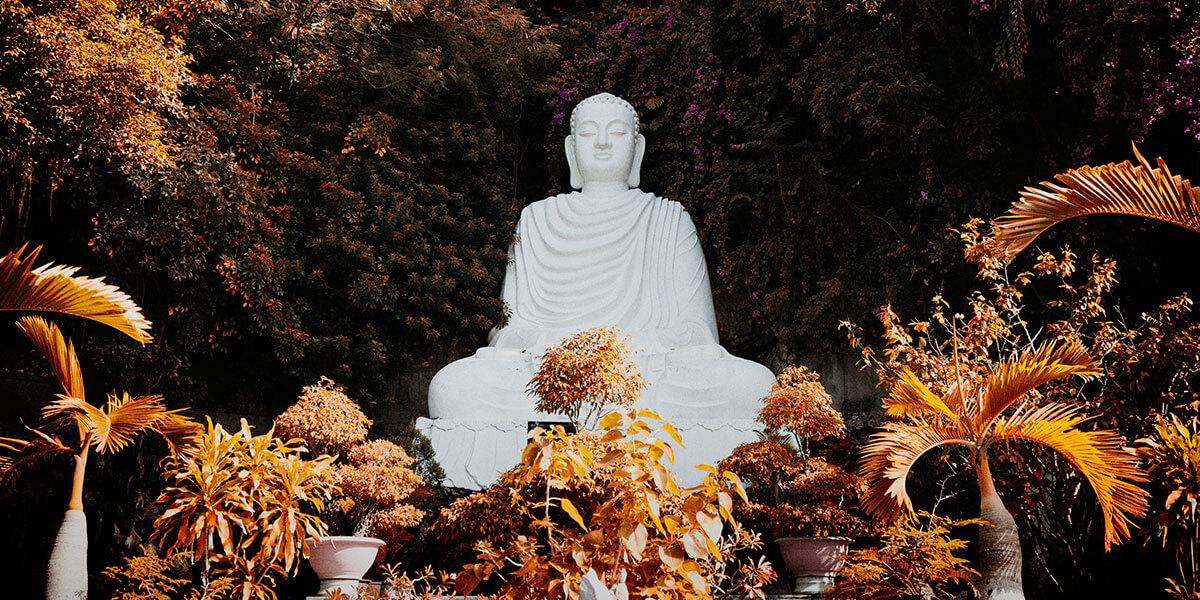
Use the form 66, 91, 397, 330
0, 246, 151, 343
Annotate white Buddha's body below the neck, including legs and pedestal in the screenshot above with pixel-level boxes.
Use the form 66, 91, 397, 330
416, 190, 775, 490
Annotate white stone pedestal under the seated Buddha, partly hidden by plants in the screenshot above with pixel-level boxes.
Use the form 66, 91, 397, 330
416, 418, 762, 490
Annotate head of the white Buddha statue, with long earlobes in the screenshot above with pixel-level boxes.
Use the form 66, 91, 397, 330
565, 94, 646, 188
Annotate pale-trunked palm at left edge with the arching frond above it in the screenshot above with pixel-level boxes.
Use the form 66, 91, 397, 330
0, 246, 199, 600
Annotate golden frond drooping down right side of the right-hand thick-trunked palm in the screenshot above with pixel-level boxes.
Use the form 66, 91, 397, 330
991, 403, 1150, 550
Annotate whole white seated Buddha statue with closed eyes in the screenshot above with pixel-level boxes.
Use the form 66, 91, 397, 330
419, 94, 774, 487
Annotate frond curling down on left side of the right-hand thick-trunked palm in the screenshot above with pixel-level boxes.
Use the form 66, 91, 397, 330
858, 422, 974, 521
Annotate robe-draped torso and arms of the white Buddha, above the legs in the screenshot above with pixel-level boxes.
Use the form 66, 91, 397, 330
488, 190, 718, 354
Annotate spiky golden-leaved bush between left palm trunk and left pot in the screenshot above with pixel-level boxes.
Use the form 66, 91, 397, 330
151, 420, 335, 600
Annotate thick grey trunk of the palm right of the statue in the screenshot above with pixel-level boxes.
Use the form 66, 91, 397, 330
976, 452, 1025, 600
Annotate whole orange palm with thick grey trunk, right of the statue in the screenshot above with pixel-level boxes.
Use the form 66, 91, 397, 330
859, 341, 1146, 600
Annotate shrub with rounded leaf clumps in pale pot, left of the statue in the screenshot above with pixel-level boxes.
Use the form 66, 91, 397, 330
275, 377, 425, 598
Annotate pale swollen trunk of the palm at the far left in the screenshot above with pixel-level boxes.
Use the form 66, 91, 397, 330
46, 448, 88, 600
